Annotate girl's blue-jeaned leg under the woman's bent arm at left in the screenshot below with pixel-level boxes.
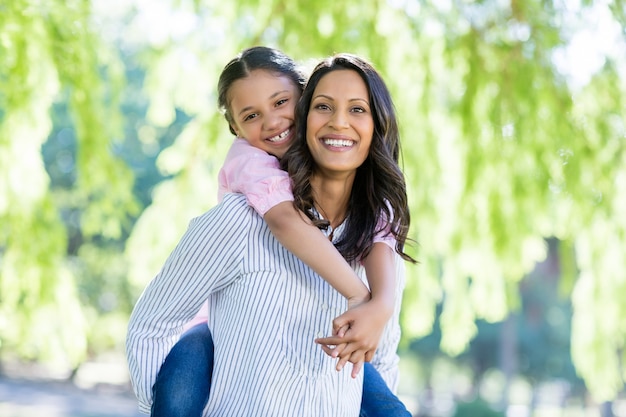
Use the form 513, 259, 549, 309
150, 323, 213, 417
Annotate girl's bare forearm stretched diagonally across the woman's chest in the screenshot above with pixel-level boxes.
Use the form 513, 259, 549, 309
263, 201, 370, 307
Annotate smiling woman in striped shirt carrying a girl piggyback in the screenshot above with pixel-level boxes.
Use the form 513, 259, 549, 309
127, 52, 408, 416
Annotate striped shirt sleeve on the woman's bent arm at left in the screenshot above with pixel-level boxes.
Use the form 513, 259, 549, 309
126, 195, 251, 413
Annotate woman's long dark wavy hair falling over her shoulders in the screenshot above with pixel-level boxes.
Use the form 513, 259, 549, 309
281, 53, 415, 262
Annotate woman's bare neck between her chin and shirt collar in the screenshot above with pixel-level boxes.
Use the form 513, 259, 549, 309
311, 177, 352, 229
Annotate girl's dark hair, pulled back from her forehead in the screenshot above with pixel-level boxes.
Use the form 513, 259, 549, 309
217, 46, 306, 135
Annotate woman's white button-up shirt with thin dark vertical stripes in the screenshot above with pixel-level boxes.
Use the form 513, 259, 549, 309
126, 194, 403, 417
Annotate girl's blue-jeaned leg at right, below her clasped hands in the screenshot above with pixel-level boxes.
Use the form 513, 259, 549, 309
360, 362, 411, 417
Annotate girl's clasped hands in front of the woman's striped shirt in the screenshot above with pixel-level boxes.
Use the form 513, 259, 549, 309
315, 299, 391, 378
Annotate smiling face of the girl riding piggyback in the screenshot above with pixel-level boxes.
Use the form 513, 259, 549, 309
228, 70, 300, 158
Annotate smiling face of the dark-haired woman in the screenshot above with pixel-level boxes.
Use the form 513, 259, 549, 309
306, 69, 374, 173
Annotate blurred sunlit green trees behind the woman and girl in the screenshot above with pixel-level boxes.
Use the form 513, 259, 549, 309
0, 0, 626, 417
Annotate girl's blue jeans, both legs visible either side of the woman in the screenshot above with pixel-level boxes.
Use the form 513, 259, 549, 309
150, 323, 411, 417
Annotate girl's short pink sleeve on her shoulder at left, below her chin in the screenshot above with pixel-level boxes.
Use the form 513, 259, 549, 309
218, 138, 293, 216
